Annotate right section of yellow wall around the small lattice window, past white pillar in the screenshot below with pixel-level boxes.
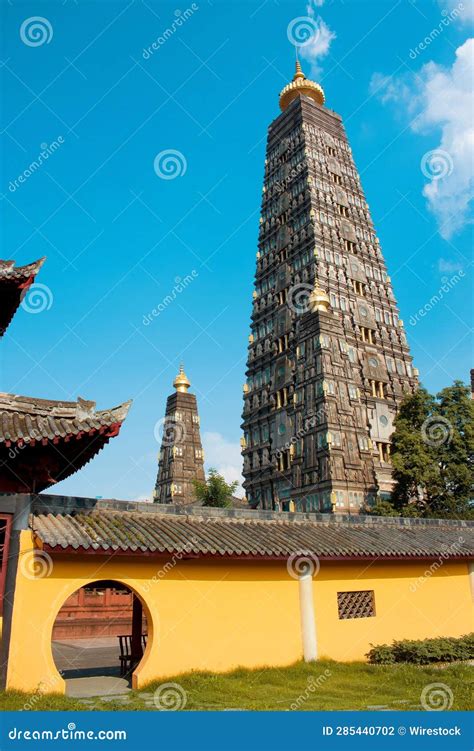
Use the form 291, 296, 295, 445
313, 562, 474, 661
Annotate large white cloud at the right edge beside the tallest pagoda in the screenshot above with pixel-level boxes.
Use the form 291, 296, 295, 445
371, 39, 474, 239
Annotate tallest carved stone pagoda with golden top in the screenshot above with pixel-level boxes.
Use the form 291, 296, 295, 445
242, 62, 417, 513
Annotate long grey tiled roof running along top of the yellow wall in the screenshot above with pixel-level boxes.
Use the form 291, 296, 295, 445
31, 496, 474, 559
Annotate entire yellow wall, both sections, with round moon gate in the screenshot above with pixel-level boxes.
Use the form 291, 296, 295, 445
7, 531, 473, 692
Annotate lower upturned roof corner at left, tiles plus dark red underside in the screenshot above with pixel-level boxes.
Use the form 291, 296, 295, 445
0, 394, 131, 493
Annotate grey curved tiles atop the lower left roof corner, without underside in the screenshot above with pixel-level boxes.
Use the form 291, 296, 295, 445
0, 392, 131, 447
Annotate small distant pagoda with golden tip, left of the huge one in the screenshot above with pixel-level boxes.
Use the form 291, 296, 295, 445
154, 366, 205, 504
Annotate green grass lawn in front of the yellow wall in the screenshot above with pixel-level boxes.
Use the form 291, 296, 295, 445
0, 660, 473, 711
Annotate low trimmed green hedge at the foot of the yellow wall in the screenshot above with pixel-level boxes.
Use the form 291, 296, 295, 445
366, 634, 474, 665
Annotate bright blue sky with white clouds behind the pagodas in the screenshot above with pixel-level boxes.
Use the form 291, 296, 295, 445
0, 0, 472, 498
